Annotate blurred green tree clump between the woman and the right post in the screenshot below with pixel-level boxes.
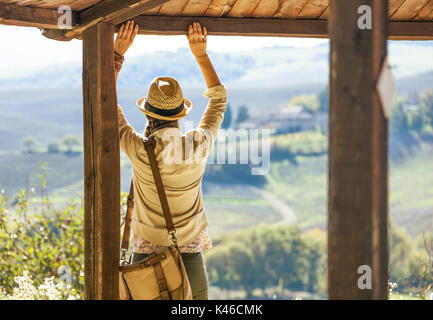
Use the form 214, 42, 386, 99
206, 226, 326, 298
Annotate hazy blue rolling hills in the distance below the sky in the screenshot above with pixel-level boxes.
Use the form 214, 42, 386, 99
0, 41, 433, 150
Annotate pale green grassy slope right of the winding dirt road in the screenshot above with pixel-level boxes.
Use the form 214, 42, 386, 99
266, 137, 433, 236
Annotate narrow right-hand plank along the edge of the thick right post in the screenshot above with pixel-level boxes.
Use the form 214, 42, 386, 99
371, 0, 389, 300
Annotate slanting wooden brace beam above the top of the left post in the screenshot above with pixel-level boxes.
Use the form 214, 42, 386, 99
65, 0, 170, 38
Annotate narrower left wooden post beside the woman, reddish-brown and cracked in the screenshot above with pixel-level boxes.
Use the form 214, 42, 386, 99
83, 23, 120, 299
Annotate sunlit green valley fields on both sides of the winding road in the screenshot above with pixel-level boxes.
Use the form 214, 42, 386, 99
0, 134, 433, 236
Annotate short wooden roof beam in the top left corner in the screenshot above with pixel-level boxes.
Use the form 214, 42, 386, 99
0, 3, 78, 28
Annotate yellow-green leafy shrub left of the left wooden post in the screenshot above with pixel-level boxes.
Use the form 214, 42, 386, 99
0, 166, 84, 298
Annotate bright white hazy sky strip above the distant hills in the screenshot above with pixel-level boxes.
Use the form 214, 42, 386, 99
0, 25, 327, 76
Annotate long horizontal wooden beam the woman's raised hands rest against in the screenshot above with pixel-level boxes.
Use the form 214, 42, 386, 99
134, 15, 433, 40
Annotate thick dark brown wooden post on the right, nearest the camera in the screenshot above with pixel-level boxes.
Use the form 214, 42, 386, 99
328, 0, 388, 299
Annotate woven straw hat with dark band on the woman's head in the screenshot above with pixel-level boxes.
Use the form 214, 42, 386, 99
137, 77, 192, 120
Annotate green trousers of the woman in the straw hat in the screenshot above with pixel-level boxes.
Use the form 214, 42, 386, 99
132, 252, 208, 300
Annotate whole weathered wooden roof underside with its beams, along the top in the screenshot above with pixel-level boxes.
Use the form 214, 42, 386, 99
0, 0, 433, 41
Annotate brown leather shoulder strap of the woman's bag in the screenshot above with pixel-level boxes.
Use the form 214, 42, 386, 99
121, 139, 177, 257
